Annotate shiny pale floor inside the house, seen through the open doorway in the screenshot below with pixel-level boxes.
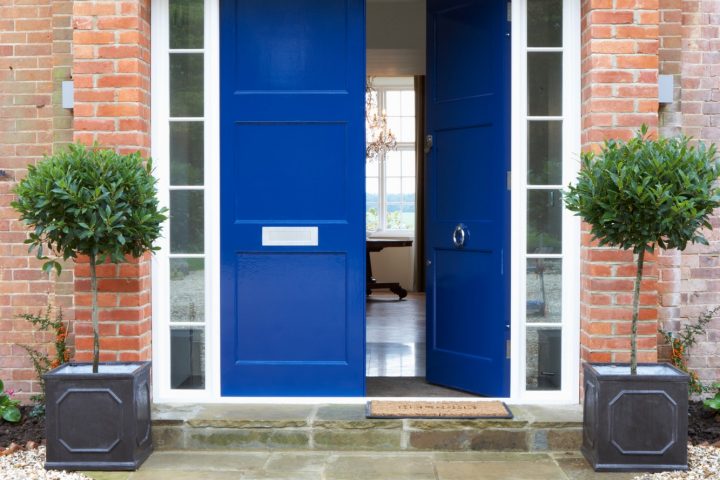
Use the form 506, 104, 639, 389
365, 292, 425, 377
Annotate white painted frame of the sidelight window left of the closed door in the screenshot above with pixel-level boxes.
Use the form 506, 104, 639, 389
151, 0, 220, 402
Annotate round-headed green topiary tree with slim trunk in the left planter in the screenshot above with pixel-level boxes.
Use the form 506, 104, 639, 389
12, 144, 167, 373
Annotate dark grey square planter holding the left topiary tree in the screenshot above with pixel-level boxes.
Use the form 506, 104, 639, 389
45, 362, 152, 470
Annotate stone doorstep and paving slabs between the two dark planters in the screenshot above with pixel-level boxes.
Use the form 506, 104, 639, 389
73, 404, 634, 480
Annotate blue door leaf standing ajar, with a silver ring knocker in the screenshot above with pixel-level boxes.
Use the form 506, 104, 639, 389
426, 0, 510, 397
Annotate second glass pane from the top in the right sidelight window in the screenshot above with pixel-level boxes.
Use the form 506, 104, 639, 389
528, 52, 562, 117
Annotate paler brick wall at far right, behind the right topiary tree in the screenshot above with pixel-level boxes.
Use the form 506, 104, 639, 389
660, 0, 720, 383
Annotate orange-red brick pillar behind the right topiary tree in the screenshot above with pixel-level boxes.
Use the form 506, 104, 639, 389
580, 0, 659, 376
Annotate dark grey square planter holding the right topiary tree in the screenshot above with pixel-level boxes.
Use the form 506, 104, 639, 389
582, 363, 689, 472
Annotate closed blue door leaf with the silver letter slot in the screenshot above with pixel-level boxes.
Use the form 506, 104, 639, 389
220, 0, 365, 396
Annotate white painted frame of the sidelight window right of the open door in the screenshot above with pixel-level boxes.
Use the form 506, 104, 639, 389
511, 0, 581, 403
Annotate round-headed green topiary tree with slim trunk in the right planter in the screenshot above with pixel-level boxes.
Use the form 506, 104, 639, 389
565, 125, 720, 375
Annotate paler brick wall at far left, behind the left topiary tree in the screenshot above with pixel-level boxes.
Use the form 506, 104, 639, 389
0, 0, 74, 400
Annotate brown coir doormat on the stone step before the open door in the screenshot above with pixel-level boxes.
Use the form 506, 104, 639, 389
367, 400, 513, 419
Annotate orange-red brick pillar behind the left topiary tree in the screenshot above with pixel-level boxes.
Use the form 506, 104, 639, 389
73, 0, 152, 361
